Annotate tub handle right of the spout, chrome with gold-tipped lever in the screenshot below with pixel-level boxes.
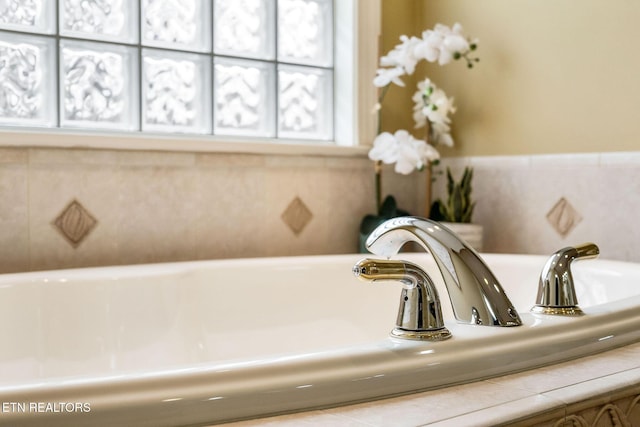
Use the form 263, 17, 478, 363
531, 243, 600, 316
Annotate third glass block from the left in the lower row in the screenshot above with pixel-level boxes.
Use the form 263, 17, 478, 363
142, 49, 211, 133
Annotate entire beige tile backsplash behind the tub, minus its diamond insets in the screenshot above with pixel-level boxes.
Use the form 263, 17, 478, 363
0, 148, 640, 272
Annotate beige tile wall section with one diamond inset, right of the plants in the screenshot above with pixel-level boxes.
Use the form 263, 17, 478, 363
434, 152, 640, 262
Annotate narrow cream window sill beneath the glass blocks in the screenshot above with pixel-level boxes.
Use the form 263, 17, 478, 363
0, 129, 369, 157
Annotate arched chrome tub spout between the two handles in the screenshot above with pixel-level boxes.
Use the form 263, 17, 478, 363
366, 217, 522, 326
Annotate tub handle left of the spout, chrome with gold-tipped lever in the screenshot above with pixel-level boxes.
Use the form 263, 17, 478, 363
353, 259, 451, 341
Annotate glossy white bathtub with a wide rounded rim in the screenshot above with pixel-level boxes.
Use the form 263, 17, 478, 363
0, 254, 640, 427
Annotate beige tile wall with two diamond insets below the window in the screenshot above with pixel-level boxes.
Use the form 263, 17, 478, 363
0, 148, 420, 273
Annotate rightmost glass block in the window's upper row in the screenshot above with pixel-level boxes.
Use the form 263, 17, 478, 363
278, 0, 333, 67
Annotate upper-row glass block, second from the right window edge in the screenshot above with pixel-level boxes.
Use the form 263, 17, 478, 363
213, 0, 275, 60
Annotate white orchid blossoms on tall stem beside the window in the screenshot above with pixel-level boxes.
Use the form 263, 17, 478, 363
369, 23, 479, 211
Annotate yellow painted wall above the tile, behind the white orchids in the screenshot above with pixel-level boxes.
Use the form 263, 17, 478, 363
382, 0, 640, 156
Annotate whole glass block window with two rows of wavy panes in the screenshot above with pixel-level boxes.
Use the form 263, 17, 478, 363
0, 0, 334, 140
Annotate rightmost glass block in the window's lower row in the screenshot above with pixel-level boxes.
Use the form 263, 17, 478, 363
278, 64, 333, 140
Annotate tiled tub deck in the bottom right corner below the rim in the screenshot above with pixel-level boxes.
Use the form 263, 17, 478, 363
222, 343, 640, 427
